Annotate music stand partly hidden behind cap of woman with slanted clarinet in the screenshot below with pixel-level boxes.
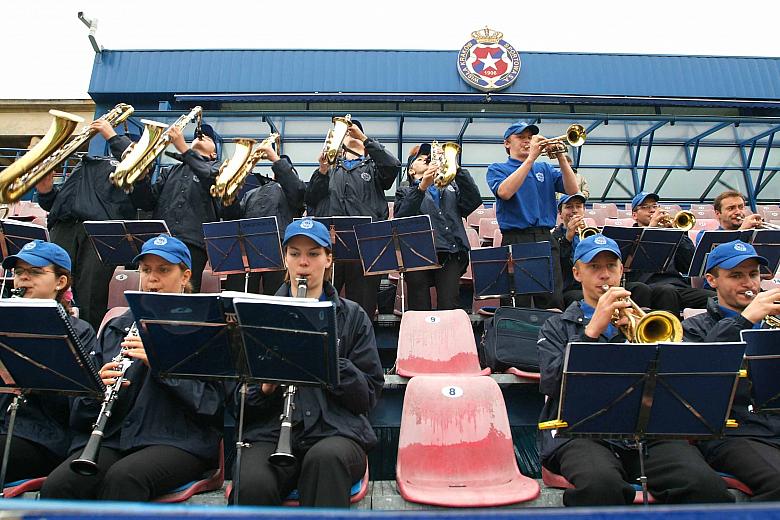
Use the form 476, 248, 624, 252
84, 220, 171, 266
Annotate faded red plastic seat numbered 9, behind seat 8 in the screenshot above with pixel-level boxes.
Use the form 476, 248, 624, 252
396, 309, 490, 377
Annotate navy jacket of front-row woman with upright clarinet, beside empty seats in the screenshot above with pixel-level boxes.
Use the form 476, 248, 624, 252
239, 282, 385, 450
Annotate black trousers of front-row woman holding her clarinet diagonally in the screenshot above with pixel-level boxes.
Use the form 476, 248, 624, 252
41, 445, 209, 502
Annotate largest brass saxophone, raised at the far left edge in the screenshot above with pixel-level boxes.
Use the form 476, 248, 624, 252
0, 103, 133, 204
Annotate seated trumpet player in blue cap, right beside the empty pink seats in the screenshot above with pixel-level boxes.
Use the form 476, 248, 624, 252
538, 235, 734, 506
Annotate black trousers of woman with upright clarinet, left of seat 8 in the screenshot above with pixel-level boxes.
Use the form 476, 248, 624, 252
228, 436, 366, 507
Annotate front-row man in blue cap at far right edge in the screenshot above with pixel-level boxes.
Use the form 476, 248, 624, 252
683, 240, 780, 500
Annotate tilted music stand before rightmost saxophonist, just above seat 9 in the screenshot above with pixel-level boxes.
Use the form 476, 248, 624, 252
355, 215, 441, 314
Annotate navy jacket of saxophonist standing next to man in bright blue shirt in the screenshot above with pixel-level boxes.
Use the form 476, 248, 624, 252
393, 168, 482, 253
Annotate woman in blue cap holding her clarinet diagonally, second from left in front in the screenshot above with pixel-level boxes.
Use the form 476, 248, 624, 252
41, 235, 224, 501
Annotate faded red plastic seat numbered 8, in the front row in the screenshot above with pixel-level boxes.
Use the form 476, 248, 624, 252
396, 376, 539, 507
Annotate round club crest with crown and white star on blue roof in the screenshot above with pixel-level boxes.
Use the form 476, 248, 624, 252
458, 27, 520, 92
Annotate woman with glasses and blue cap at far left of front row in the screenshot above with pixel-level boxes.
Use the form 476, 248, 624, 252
0, 240, 96, 482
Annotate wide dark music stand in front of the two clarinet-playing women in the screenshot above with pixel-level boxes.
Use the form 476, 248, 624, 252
125, 291, 339, 502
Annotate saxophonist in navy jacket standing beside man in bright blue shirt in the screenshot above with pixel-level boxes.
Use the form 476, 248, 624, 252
393, 143, 482, 311
